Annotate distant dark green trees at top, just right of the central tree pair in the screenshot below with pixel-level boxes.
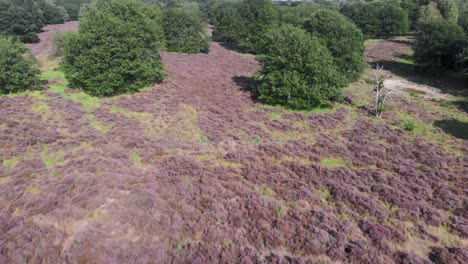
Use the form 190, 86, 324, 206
340, 1, 409, 38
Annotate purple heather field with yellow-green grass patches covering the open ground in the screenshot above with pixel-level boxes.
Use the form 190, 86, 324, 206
0, 24, 468, 263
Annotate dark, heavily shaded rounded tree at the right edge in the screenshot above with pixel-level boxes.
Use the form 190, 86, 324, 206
413, 20, 466, 73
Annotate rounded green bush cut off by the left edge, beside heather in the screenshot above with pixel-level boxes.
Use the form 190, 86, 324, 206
0, 37, 40, 94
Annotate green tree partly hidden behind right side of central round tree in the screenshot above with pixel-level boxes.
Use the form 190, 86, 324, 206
304, 9, 366, 81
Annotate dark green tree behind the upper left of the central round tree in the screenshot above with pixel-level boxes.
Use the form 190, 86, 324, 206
237, 0, 277, 52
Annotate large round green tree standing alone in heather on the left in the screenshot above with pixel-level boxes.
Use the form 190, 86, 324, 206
63, 0, 165, 96
